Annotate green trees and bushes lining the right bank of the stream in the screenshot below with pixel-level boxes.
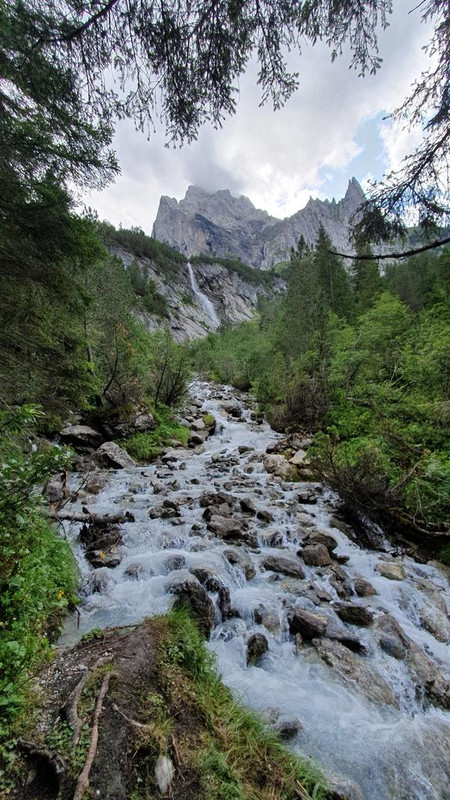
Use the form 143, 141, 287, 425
192, 231, 450, 552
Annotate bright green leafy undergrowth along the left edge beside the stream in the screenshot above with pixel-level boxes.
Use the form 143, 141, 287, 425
0, 406, 77, 755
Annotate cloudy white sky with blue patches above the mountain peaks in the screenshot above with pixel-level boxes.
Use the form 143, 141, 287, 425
83, 0, 430, 233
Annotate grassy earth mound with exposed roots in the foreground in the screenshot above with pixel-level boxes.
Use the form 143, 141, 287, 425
5, 610, 329, 800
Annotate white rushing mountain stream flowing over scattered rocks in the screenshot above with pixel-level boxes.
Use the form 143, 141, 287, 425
60, 381, 450, 800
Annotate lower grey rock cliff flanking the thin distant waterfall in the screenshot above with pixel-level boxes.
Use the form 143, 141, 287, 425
114, 246, 284, 342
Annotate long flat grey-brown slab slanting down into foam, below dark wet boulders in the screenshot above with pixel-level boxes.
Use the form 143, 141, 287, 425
313, 639, 398, 707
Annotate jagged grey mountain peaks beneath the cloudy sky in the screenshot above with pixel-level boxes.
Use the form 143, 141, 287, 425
153, 178, 364, 269
